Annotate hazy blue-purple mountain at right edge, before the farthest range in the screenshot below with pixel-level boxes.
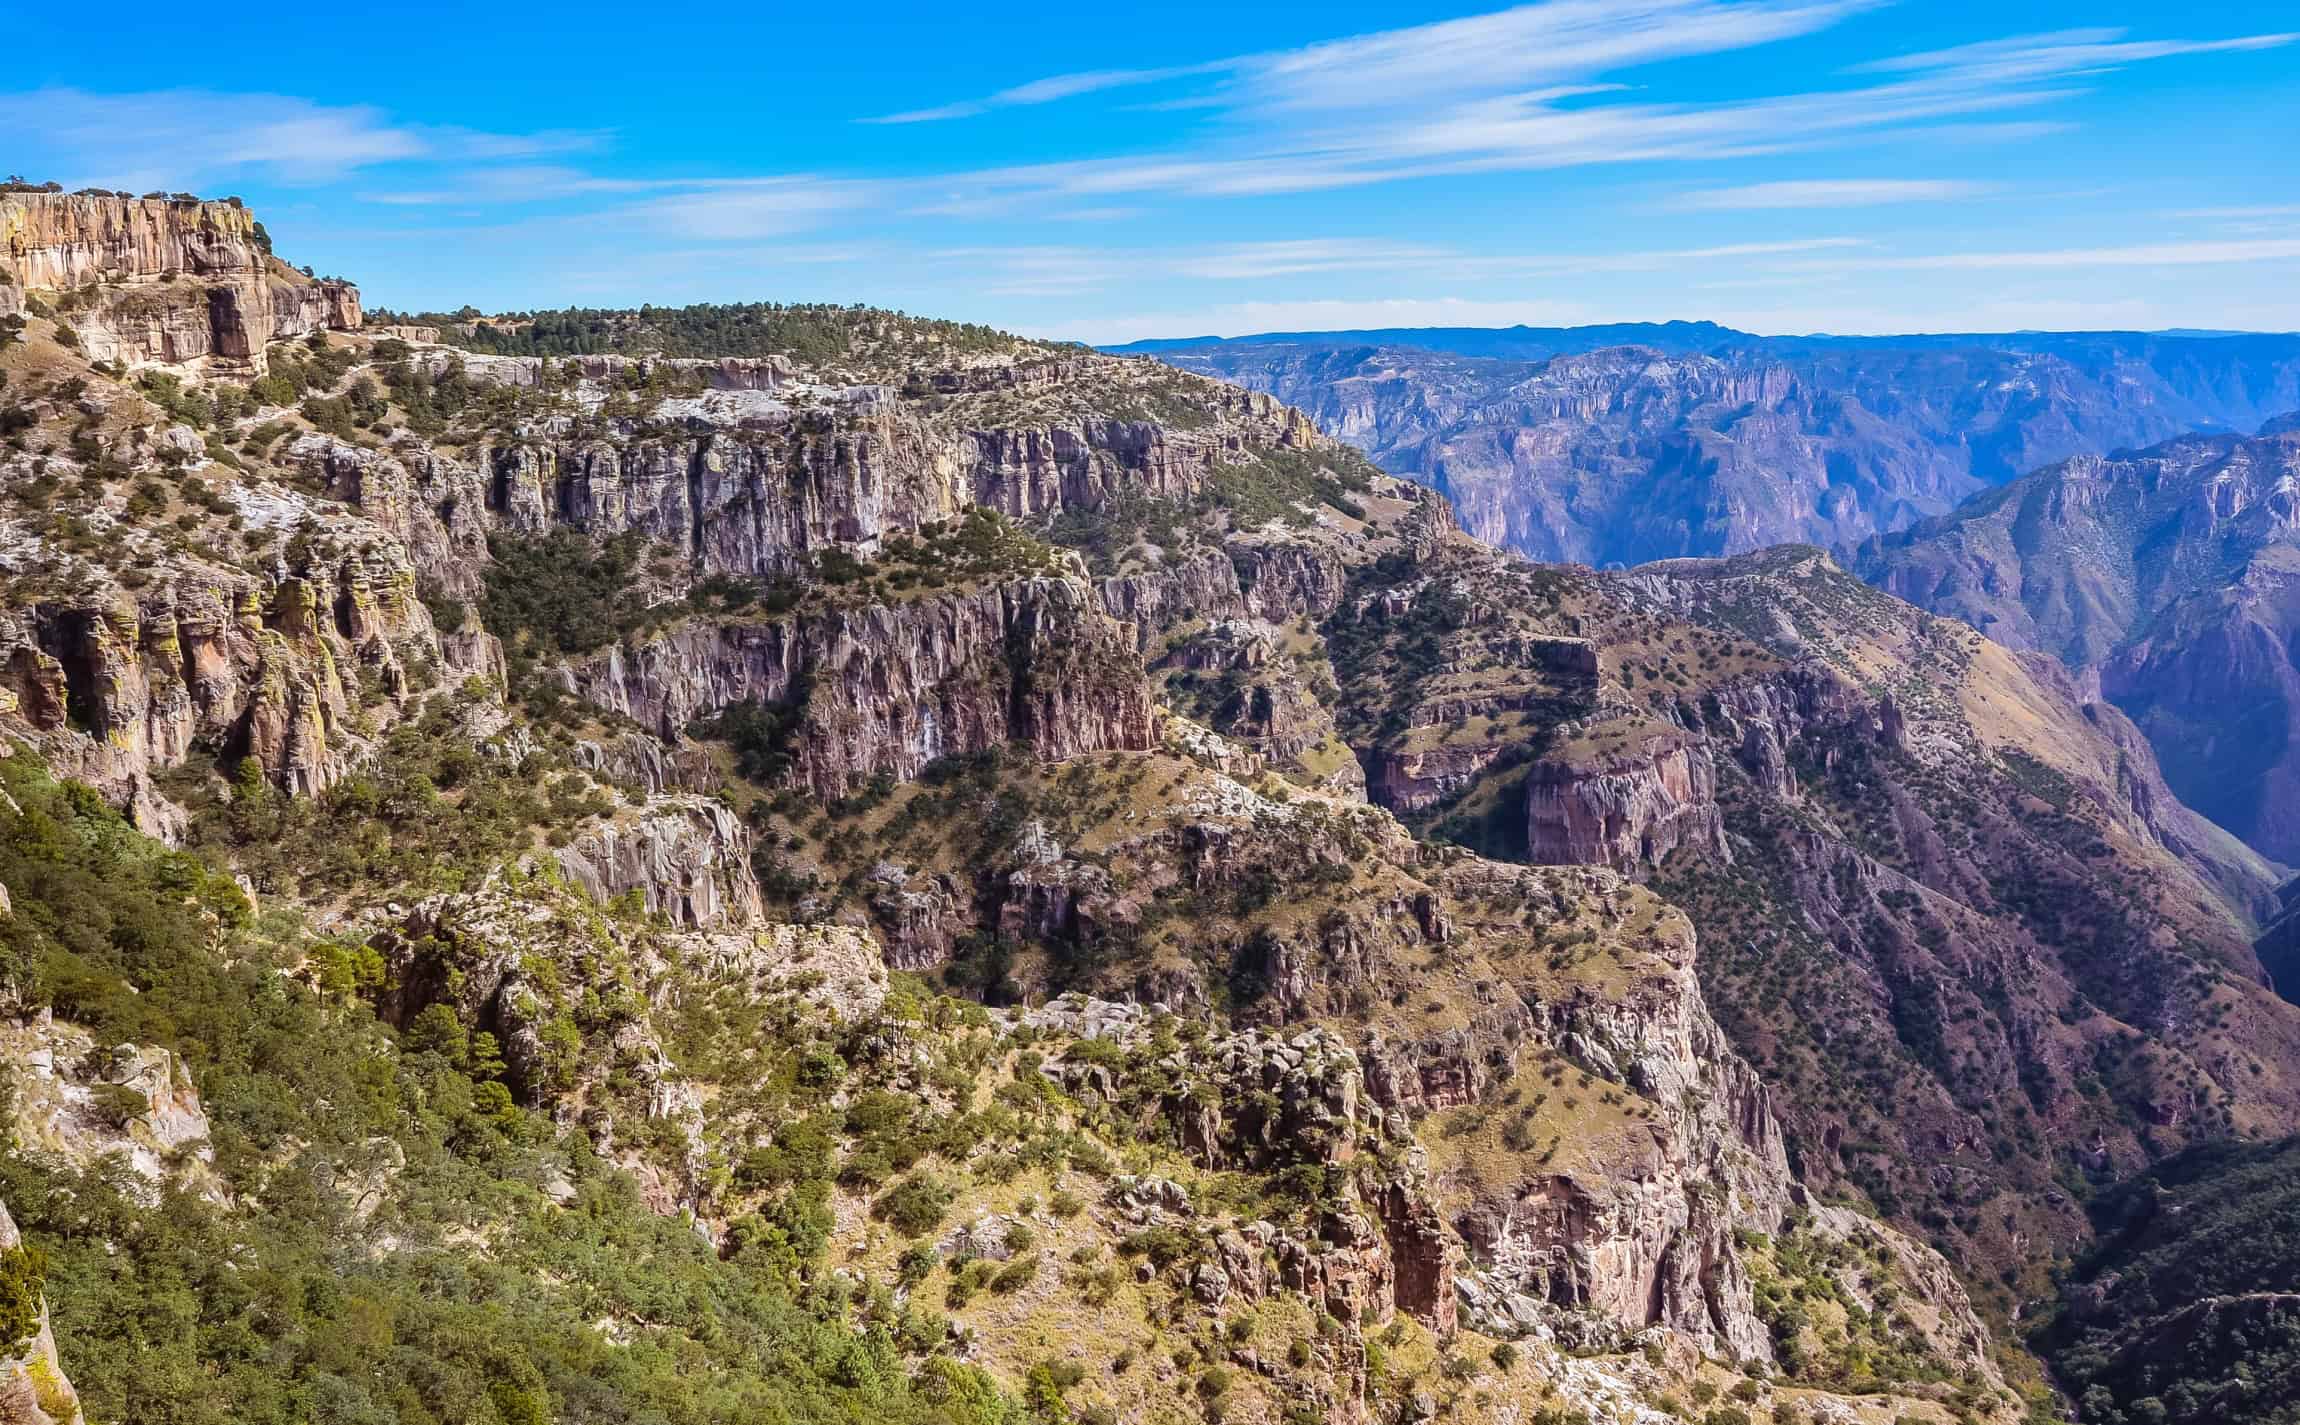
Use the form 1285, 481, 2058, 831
1856, 418, 2300, 862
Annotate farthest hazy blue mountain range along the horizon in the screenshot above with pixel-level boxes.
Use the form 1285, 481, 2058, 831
1127, 322, 2300, 565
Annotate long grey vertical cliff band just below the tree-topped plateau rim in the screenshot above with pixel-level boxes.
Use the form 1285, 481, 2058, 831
292, 352, 1313, 591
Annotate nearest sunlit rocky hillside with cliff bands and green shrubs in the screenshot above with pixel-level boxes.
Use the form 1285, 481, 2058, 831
0, 195, 2033, 1425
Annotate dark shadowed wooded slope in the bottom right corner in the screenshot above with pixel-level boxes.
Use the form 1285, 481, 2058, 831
2038, 1140, 2300, 1425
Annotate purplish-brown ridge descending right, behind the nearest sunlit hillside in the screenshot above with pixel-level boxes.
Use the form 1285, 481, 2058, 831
1278, 519, 2300, 1305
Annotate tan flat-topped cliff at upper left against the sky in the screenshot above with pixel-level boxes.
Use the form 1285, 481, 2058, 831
0, 193, 361, 372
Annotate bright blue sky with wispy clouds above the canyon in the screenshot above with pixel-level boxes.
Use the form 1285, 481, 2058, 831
0, 0, 2300, 340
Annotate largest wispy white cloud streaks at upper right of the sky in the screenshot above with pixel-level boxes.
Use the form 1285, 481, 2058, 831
837, 13, 2293, 205
